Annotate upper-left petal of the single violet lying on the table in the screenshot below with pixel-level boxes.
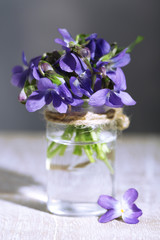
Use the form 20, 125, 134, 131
97, 195, 119, 209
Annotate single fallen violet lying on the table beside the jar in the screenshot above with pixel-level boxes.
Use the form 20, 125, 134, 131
98, 188, 142, 224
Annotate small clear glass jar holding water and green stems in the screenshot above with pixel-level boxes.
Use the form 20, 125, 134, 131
46, 104, 117, 216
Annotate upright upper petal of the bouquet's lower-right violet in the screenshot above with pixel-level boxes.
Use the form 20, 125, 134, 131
107, 68, 127, 91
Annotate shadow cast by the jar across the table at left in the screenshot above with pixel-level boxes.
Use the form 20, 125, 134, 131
0, 168, 48, 212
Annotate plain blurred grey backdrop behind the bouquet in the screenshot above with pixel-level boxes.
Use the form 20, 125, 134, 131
0, 0, 160, 133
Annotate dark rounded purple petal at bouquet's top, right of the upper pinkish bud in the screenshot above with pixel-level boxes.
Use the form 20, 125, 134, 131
96, 38, 110, 58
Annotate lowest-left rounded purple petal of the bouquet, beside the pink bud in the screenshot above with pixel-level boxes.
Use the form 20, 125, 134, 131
26, 91, 46, 112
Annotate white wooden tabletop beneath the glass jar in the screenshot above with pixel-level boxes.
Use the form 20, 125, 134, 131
0, 133, 160, 240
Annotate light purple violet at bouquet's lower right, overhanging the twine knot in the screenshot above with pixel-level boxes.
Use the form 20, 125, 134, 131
89, 68, 136, 107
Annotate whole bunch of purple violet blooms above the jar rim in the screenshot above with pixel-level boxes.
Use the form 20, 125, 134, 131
11, 29, 136, 113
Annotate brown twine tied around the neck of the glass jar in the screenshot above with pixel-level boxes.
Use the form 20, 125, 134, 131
44, 108, 130, 130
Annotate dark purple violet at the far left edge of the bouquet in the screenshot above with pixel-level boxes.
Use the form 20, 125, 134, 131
11, 52, 41, 88
